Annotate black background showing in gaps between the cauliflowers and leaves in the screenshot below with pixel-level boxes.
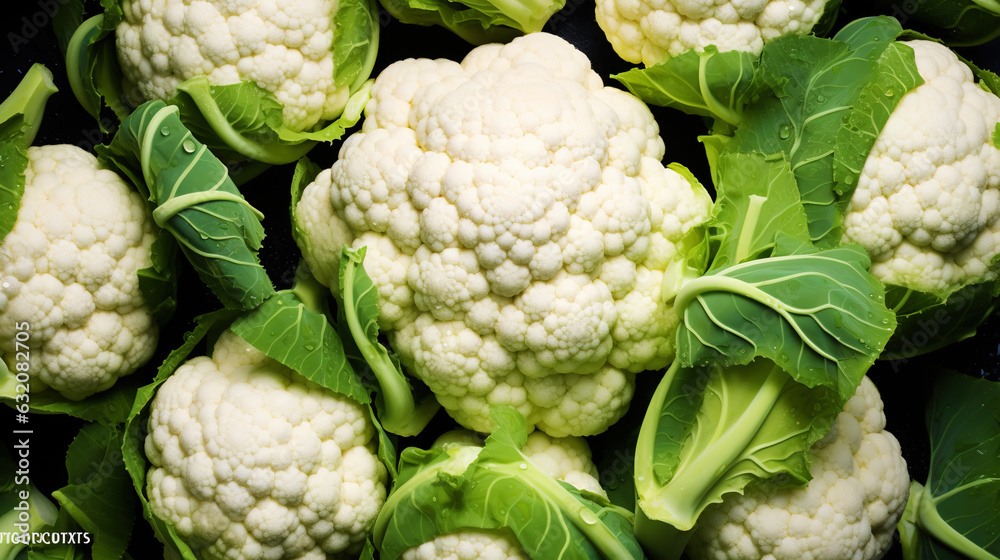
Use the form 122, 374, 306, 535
0, 0, 1000, 558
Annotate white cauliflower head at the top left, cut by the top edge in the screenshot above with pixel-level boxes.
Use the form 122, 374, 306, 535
115, 0, 349, 131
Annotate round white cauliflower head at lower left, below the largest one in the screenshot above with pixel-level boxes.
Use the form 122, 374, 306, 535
145, 331, 387, 560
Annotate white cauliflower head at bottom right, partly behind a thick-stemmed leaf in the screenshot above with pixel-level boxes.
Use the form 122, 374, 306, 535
686, 377, 910, 560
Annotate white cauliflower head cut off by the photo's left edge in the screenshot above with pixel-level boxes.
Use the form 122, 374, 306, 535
0, 145, 159, 400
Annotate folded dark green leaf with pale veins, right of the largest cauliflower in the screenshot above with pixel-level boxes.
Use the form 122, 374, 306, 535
674, 246, 896, 401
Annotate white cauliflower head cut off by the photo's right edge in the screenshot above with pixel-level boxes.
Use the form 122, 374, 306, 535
843, 41, 1000, 294
